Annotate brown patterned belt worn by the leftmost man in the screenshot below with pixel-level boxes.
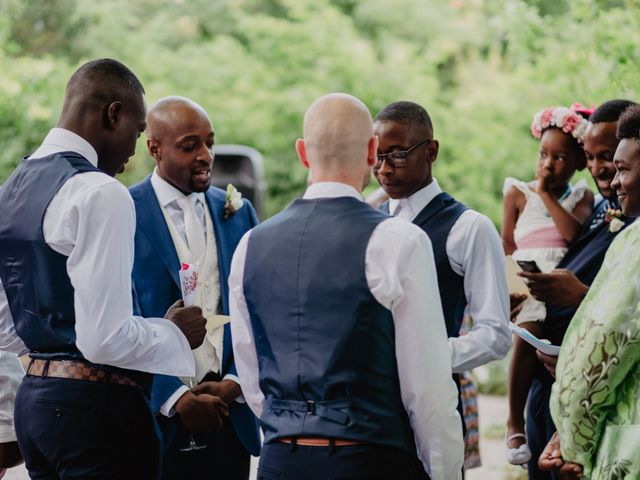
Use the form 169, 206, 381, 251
27, 358, 142, 388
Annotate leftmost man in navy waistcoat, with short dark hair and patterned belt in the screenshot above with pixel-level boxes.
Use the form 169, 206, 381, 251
0, 59, 206, 480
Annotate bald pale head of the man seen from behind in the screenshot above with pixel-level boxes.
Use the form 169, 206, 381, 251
304, 93, 373, 177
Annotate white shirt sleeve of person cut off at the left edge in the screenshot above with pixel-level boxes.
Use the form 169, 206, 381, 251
0, 351, 24, 443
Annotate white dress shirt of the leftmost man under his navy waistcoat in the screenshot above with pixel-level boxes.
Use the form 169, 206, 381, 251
0, 128, 195, 377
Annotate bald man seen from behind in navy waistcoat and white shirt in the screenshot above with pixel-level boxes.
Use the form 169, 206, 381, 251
229, 94, 463, 480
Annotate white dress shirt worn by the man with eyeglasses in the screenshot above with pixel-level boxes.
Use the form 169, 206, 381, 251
389, 178, 511, 373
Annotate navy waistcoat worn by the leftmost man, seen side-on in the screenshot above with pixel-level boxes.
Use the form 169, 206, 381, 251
0, 152, 149, 386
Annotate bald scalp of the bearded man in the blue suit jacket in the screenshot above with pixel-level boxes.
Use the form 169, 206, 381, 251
146, 95, 211, 142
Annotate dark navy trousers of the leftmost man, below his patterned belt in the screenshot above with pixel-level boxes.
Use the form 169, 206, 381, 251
15, 376, 160, 480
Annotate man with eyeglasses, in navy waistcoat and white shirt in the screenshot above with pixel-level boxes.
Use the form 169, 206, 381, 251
373, 102, 511, 458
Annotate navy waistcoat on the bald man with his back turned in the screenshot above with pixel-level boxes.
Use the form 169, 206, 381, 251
244, 197, 415, 451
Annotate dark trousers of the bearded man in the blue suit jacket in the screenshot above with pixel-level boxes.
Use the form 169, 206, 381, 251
162, 408, 250, 480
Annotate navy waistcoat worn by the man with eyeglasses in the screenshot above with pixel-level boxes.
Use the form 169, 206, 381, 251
380, 192, 468, 338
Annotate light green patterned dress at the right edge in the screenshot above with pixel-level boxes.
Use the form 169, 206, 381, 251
551, 221, 640, 480
